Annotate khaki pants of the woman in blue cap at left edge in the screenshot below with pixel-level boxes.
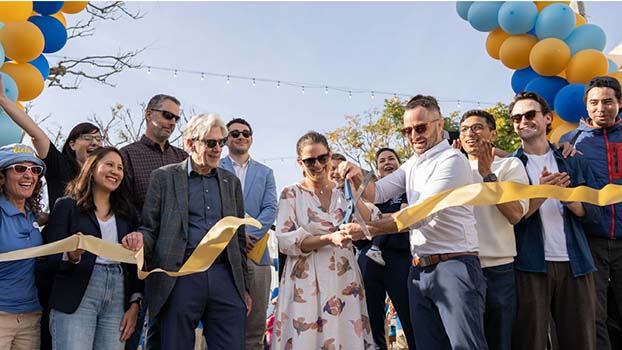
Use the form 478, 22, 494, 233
0, 311, 41, 350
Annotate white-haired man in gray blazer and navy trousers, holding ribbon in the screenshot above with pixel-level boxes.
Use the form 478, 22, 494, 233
139, 113, 251, 350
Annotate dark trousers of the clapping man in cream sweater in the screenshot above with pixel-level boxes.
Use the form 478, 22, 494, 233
482, 263, 516, 350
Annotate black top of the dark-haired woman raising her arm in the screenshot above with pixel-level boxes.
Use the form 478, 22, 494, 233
43, 140, 78, 211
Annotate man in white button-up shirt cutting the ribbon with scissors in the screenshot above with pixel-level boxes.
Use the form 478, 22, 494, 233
340, 95, 487, 350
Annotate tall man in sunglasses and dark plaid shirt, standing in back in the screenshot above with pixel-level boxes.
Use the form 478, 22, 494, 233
121, 94, 188, 350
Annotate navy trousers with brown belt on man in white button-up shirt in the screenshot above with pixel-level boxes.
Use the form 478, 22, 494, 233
408, 256, 488, 350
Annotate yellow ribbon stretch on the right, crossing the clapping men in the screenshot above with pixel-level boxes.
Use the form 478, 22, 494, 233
393, 181, 622, 231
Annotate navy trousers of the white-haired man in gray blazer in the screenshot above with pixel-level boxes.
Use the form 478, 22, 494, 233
157, 264, 246, 350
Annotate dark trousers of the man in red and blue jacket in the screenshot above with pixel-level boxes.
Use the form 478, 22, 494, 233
588, 236, 622, 350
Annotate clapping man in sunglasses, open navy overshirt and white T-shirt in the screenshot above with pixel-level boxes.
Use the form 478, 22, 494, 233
509, 92, 601, 350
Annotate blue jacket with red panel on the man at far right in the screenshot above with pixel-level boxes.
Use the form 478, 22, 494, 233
560, 117, 622, 239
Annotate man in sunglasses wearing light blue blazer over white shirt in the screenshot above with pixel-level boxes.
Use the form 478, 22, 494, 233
220, 118, 277, 350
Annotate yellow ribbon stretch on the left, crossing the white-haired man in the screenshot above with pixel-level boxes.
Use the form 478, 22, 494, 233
0, 216, 261, 279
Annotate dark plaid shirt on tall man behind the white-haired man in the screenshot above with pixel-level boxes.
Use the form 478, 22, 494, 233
121, 135, 188, 212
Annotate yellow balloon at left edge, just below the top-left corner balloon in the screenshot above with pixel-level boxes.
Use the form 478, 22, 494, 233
0, 21, 44, 62
